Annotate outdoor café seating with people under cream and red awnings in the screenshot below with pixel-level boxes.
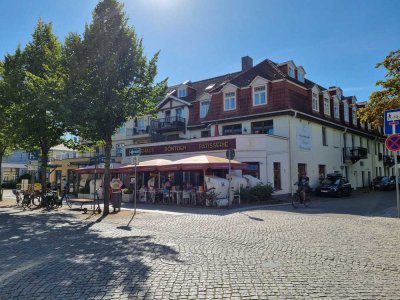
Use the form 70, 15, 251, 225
75, 155, 247, 206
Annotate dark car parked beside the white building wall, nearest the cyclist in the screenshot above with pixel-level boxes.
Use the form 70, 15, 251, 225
316, 173, 351, 197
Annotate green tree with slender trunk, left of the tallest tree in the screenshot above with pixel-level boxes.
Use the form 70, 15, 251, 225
5, 19, 65, 197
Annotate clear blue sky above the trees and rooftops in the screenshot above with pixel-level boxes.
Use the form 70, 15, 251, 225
0, 0, 400, 102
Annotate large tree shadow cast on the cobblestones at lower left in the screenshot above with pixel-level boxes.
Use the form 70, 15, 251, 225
0, 212, 177, 299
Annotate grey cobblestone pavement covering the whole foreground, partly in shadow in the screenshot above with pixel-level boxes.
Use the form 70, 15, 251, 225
0, 195, 400, 300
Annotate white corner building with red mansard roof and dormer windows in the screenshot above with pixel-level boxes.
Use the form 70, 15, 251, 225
120, 56, 392, 195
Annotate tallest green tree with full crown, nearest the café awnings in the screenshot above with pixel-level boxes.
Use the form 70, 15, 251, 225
65, 0, 166, 215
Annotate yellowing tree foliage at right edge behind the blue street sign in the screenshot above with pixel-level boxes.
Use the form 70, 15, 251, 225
358, 49, 400, 128
